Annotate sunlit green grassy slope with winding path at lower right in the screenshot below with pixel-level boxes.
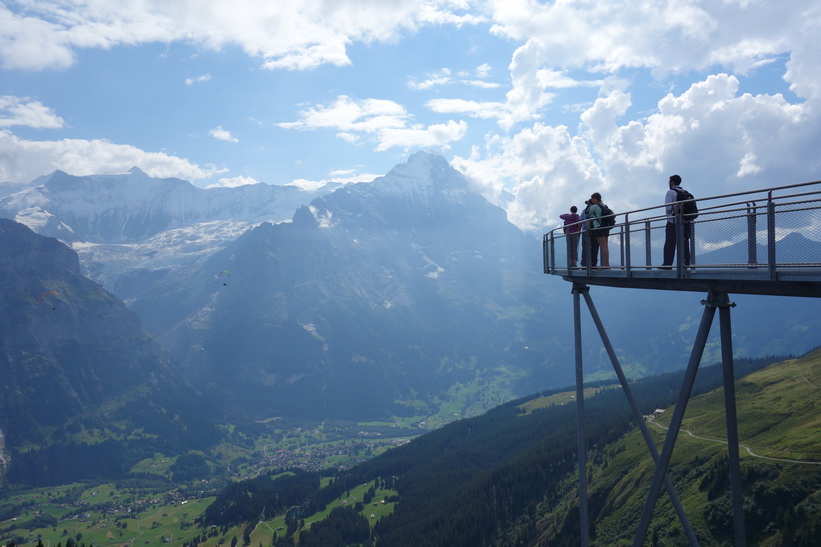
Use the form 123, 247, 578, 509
540, 350, 821, 545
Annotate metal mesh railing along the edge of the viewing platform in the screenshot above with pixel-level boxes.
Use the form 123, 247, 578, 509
543, 181, 821, 280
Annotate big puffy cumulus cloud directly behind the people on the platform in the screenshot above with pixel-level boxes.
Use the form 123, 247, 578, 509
453, 74, 821, 230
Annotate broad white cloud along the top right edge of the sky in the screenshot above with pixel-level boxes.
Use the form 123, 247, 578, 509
490, 0, 821, 90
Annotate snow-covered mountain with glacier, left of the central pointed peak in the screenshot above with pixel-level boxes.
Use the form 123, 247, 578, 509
0, 168, 338, 299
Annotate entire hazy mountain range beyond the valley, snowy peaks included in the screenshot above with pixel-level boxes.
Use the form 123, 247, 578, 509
0, 152, 821, 426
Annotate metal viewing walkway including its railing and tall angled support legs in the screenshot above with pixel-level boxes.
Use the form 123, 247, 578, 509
543, 181, 821, 547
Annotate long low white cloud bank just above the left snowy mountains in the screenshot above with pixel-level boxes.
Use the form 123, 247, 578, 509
0, 130, 223, 182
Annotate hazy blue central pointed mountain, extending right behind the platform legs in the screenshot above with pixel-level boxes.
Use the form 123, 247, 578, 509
115, 153, 821, 417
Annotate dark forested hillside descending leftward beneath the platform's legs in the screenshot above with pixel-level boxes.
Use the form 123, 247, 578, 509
194, 352, 821, 546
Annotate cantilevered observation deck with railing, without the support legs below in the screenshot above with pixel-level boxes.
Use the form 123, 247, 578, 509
543, 181, 821, 297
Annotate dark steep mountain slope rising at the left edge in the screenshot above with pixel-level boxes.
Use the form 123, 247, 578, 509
0, 219, 221, 483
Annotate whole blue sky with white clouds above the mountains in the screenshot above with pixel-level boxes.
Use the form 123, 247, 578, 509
0, 0, 821, 232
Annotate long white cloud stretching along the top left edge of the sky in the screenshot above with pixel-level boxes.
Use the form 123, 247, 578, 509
0, 0, 484, 70
